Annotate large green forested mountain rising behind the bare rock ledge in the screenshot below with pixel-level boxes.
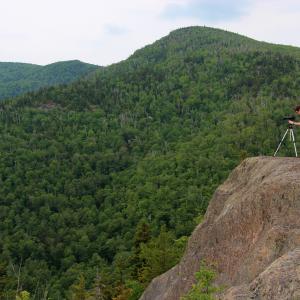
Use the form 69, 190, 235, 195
0, 27, 300, 300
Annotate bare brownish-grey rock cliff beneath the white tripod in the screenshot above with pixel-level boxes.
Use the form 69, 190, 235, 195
141, 157, 300, 300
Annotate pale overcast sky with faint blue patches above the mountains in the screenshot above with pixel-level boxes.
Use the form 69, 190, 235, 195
0, 0, 300, 65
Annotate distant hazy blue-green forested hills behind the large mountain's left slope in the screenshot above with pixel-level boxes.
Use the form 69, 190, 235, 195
0, 60, 98, 100
